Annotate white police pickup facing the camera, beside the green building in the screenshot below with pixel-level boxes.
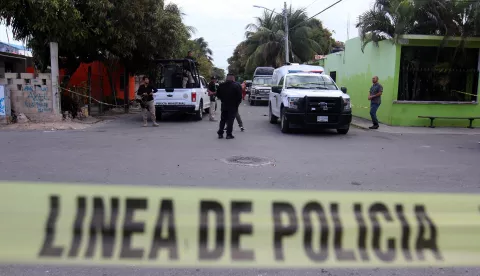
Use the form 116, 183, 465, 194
268, 65, 352, 134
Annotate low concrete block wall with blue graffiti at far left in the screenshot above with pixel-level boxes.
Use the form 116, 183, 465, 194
0, 73, 61, 122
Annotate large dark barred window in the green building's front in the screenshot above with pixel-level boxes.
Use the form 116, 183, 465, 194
398, 46, 479, 102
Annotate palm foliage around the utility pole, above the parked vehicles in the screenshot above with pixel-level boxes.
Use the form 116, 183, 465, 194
228, 7, 335, 78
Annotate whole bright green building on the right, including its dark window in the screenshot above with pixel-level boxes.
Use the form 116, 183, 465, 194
321, 35, 480, 127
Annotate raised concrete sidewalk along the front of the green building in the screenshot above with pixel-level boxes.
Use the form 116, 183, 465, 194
352, 117, 480, 135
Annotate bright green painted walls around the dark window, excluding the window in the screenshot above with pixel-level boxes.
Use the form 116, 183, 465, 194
324, 36, 480, 127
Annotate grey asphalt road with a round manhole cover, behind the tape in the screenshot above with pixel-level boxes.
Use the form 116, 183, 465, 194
0, 101, 480, 276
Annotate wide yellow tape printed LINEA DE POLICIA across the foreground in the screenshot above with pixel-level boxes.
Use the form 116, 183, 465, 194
0, 183, 480, 268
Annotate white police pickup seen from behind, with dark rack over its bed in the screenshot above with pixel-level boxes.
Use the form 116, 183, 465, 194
154, 59, 210, 121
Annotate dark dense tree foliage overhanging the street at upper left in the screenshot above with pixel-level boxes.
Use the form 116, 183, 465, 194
0, 0, 189, 73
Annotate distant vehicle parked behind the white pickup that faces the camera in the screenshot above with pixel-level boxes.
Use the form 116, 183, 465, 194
248, 67, 275, 105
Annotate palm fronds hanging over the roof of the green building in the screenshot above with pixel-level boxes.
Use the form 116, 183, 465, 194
357, 0, 480, 50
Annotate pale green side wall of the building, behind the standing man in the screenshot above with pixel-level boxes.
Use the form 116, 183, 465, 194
324, 38, 400, 124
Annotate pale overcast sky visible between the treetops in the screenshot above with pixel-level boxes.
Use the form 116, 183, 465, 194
0, 0, 374, 69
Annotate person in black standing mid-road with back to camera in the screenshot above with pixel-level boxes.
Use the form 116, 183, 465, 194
217, 74, 242, 139
